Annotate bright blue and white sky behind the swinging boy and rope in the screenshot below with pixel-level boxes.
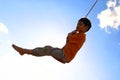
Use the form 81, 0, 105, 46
0, 0, 120, 80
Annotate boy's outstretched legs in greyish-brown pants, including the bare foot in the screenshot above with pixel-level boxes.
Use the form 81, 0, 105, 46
12, 45, 67, 63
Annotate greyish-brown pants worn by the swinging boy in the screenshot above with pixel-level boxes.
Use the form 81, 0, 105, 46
32, 46, 67, 63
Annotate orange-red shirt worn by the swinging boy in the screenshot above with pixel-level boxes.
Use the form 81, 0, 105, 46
62, 33, 86, 62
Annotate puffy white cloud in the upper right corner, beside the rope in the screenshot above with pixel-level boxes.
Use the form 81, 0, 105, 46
97, 0, 120, 32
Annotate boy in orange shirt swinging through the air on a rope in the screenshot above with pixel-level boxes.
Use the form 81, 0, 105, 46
12, 18, 91, 63
